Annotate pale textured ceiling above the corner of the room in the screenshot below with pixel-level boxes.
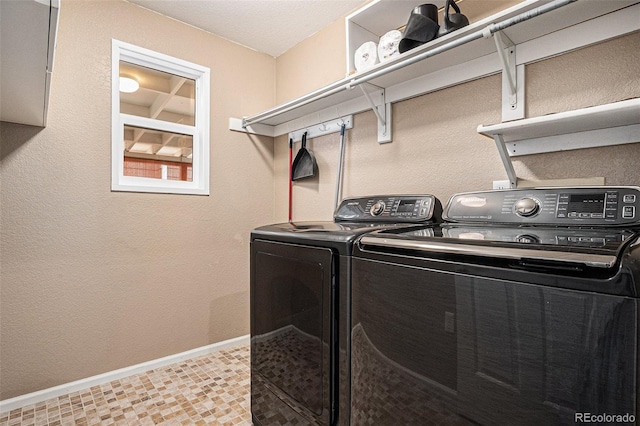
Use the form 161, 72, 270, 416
128, 0, 367, 57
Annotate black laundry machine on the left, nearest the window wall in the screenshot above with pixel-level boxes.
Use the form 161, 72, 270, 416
250, 195, 442, 425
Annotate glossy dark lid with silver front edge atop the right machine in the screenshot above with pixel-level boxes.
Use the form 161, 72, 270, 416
360, 225, 638, 268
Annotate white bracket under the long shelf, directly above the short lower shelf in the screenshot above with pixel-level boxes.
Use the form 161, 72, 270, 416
485, 31, 525, 121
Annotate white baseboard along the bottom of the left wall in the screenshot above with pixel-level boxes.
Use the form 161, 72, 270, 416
0, 334, 250, 413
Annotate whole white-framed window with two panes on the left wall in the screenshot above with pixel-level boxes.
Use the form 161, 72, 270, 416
111, 40, 210, 195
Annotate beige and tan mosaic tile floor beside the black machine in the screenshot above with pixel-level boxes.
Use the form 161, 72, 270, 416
0, 345, 251, 426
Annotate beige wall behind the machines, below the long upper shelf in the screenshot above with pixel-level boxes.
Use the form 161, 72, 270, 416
275, 33, 640, 220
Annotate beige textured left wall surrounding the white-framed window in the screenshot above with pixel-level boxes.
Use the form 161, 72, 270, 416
0, 0, 275, 400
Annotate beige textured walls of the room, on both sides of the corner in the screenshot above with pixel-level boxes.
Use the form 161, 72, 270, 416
0, 0, 640, 400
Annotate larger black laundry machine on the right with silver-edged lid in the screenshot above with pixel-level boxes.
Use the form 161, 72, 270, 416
351, 187, 640, 426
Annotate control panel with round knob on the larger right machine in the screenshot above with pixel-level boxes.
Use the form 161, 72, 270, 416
443, 186, 640, 226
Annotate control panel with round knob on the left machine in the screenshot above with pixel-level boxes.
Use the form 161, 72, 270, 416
334, 194, 440, 223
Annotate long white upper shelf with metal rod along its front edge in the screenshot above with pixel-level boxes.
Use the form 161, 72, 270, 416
236, 0, 638, 131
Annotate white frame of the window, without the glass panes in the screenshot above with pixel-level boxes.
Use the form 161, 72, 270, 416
111, 40, 211, 195
